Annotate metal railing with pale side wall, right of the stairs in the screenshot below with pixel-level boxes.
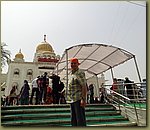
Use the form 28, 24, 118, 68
100, 83, 146, 126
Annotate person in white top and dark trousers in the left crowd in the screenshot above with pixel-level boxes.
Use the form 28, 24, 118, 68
30, 76, 40, 105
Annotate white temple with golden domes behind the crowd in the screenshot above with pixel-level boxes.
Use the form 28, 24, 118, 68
5, 35, 60, 96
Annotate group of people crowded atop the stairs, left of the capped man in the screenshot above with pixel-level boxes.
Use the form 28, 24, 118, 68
3, 72, 66, 106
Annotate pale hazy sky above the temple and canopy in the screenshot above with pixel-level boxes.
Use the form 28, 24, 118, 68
1, 1, 146, 82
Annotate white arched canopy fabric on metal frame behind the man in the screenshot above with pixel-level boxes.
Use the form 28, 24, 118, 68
56, 43, 134, 79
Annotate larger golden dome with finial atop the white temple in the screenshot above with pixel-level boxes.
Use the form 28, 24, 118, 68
36, 35, 54, 53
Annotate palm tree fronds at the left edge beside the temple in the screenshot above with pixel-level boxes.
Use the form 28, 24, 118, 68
1, 42, 11, 68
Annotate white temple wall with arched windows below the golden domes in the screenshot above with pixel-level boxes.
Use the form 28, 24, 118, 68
5, 62, 55, 96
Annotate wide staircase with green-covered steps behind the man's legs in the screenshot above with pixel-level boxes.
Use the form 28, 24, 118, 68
1, 104, 136, 127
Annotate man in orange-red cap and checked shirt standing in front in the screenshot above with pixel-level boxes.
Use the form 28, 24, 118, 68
67, 58, 87, 126
